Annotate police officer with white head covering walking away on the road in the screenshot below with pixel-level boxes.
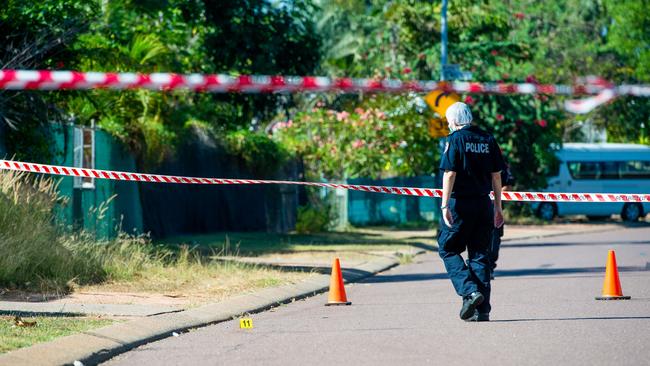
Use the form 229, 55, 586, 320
438, 102, 505, 321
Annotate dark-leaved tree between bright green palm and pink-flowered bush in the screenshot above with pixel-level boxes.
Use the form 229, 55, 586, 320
203, 0, 320, 129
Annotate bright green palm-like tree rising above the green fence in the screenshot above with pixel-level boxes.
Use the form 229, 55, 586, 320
54, 0, 207, 167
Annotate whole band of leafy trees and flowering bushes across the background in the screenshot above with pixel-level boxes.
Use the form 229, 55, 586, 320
0, 0, 650, 187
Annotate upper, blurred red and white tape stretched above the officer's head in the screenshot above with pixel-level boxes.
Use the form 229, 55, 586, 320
0, 70, 650, 97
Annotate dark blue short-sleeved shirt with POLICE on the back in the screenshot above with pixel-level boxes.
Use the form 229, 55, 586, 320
440, 126, 506, 198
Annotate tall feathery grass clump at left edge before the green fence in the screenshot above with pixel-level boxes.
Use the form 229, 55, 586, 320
0, 171, 105, 289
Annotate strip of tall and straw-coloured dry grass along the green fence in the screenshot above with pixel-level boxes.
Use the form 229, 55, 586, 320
0, 171, 308, 299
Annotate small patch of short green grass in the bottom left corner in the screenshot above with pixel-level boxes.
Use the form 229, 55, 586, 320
0, 316, 114, 353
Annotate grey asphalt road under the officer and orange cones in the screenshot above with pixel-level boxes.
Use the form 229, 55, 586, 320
107, 226, 650, 365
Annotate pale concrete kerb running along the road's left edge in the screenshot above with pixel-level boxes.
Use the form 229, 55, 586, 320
0, 251, 400, 365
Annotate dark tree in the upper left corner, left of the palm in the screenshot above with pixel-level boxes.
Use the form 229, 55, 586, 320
0, 0, 94, 161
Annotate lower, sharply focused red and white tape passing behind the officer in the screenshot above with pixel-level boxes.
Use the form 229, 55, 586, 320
0, 160, 650, 202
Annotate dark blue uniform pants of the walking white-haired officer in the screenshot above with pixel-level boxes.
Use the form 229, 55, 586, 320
438, 196, 494, 313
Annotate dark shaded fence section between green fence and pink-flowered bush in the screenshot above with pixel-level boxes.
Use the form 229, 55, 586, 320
140, 133, 301, 238
